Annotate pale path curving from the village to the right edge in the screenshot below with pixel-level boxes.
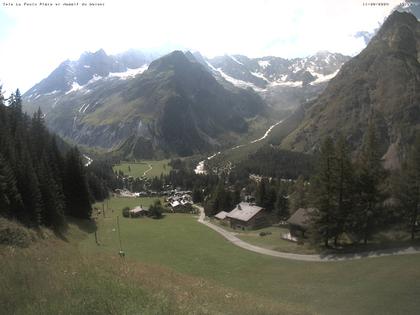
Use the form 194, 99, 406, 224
196, 206, 420, 262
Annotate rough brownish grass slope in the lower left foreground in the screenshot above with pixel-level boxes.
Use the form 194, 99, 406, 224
0, 217, 303, 315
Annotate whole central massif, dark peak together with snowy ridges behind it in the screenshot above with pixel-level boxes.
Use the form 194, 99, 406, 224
23, 50, 350, 158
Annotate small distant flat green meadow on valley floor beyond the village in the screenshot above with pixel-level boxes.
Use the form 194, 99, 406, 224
113, 160, 172, 178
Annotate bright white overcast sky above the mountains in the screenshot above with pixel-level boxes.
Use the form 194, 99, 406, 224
0, 0, 401, 93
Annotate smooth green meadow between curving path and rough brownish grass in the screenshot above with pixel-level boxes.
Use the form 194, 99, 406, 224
82, 201, 420, 314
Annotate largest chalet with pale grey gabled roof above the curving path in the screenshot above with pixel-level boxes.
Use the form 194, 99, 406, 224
226, 202, 268, 230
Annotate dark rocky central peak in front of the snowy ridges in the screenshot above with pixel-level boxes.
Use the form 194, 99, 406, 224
26, 51, 267, 157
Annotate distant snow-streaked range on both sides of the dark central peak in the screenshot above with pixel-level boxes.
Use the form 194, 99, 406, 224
24, 49, 350, 113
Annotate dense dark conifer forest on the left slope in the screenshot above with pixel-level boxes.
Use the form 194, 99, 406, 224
0, 90, 92, 229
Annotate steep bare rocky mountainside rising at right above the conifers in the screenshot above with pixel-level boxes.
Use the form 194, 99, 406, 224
282, 11, 420, 163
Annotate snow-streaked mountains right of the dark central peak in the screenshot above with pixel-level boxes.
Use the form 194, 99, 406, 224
194, 51, 350, 108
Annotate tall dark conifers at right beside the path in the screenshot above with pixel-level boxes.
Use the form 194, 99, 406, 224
308, 124, 420, 247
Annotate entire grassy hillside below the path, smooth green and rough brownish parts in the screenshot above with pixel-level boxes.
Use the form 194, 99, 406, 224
0, 198, 420, 314
